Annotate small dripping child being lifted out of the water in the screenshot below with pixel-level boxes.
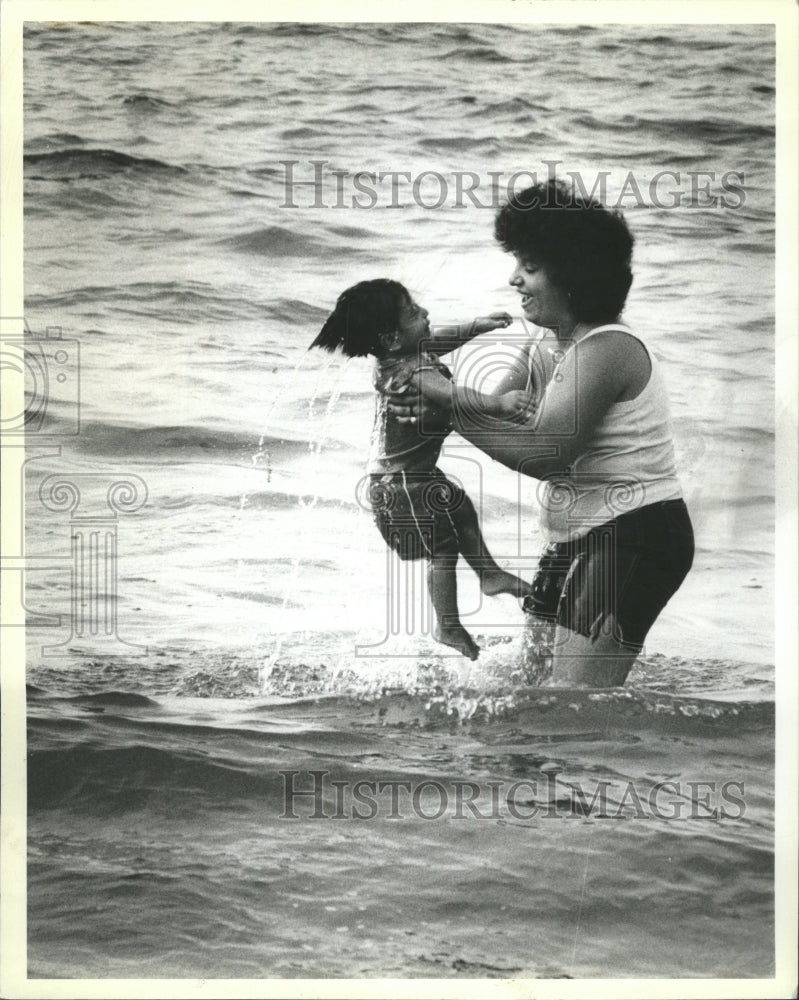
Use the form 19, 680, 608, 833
311, 278, 530, 660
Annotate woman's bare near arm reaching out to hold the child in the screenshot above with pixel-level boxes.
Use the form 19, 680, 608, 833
414, 331, 629, 479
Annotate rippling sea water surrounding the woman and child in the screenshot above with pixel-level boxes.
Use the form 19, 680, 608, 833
25, 24, 774, 978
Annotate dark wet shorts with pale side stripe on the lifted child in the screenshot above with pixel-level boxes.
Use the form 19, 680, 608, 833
369, 469, 465, 559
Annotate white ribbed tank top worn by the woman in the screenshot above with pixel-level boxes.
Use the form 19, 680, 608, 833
539, 324, 682, 542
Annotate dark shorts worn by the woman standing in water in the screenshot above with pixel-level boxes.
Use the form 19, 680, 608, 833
524, 500, 694, 647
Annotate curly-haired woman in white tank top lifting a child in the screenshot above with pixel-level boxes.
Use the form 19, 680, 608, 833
392, 181, 694, 687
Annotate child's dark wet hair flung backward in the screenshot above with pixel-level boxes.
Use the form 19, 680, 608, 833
309, 278, 411, 358
